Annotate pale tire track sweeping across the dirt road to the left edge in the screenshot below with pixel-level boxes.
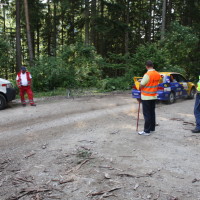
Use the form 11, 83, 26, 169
0, 104, 137, 146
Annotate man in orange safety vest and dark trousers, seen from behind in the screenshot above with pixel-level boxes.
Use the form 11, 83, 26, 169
138, 60, 161, 136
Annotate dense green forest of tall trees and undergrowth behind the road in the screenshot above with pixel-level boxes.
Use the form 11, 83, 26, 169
0, 0, 200, 91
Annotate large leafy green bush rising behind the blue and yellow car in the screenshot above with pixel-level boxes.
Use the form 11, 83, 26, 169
160, 22, 200, 77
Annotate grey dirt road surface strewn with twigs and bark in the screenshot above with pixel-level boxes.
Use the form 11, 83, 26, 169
0, 92, 200, 200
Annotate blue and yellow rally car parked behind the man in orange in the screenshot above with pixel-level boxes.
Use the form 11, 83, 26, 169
132, 72, 196, 104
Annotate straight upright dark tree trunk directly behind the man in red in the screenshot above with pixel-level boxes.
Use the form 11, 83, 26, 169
16, 0, 22, 72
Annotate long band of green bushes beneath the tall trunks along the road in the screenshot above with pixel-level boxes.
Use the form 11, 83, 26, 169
28, 24, 198, 91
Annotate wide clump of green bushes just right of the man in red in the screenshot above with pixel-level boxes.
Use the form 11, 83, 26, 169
31, 44, 101, 91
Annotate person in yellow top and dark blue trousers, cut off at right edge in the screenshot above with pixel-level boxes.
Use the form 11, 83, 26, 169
192, 76, 200, 133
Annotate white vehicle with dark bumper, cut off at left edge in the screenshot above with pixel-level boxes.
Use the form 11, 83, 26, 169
0, 78, 16, 110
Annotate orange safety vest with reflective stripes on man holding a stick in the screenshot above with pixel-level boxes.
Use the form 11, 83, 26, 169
141, 71, 161, 96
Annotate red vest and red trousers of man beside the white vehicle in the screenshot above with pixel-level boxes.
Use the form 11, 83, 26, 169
17, 72, 34, 105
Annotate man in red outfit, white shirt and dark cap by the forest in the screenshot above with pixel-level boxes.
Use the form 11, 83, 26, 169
16, 66, 36, 107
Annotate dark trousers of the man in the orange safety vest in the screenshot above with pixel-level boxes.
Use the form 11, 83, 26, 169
142, 100, 156, 133
